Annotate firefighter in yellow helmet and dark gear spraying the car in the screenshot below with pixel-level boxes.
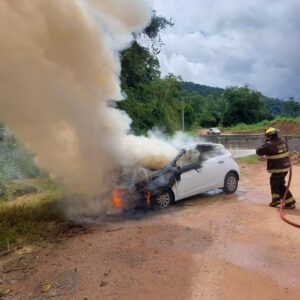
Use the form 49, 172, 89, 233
256, 127, 296, 209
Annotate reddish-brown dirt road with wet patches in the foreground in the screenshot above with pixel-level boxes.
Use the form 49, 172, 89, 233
0, 164, 300, 300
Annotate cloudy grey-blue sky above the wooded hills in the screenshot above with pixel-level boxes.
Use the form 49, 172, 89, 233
148, 0, 300, 100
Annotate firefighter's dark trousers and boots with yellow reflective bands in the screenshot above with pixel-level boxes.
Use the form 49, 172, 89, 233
270, 172, 296, 207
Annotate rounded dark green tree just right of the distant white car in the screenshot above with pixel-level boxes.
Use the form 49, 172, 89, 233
223, 85, 264, 126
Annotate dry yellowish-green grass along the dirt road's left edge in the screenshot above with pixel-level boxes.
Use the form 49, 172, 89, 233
0, 179, 64, 253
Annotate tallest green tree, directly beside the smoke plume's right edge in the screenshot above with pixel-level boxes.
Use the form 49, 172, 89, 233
117, 11, 177, 134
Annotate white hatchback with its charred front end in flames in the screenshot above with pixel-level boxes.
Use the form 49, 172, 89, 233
113, 143, 240, 209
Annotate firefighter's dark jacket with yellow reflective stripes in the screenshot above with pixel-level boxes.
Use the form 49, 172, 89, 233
256, 136, 291, 173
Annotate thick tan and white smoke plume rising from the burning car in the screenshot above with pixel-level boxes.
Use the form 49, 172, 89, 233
0, 0, 175, 202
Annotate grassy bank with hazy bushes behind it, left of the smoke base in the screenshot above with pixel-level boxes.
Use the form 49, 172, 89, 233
0, 127, 64, 253
